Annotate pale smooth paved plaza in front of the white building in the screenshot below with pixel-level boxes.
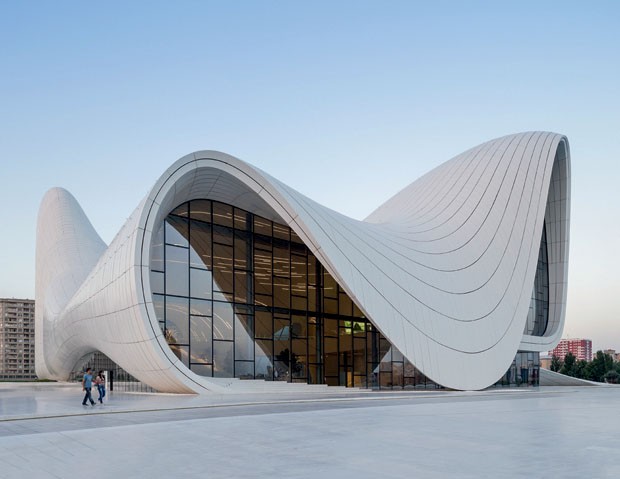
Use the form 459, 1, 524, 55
0, 384, 620, 478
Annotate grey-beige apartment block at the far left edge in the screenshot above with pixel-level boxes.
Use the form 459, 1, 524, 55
0, 298, 36, 380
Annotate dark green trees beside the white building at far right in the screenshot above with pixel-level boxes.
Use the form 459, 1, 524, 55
549, 351, 620, 384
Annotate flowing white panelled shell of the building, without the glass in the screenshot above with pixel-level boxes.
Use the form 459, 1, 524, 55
36, 132, 570, 392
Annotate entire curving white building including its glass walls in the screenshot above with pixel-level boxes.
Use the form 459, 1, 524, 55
36, 132, 570, 393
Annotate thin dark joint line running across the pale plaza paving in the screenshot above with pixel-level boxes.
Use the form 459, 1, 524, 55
0, 389, 556, 423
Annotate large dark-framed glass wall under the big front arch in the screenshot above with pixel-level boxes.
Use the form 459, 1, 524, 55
151, 200, 439, 388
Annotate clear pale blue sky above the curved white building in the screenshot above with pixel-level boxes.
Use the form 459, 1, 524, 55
0, 0, 620, 349
